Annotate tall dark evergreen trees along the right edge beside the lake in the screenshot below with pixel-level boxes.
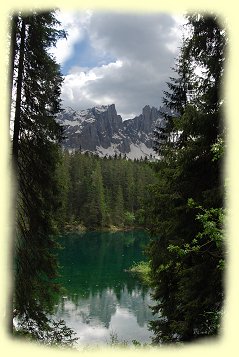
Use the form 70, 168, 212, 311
146, 14, 226, 343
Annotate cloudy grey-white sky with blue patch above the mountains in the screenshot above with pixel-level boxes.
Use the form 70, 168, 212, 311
54, 10, 186, 119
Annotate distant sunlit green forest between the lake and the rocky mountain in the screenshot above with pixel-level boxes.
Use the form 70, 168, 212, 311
56, 151, 156, 229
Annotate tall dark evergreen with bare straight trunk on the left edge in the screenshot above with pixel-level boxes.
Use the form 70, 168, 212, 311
10, 11, 76, 343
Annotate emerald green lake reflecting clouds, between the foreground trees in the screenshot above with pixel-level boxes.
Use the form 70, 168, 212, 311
54, 231, 157, 345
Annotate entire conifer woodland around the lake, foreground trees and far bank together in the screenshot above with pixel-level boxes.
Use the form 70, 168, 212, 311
9, 11, 227, 345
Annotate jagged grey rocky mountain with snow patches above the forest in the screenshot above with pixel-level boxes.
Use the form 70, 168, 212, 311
57, 104, 162, 159
